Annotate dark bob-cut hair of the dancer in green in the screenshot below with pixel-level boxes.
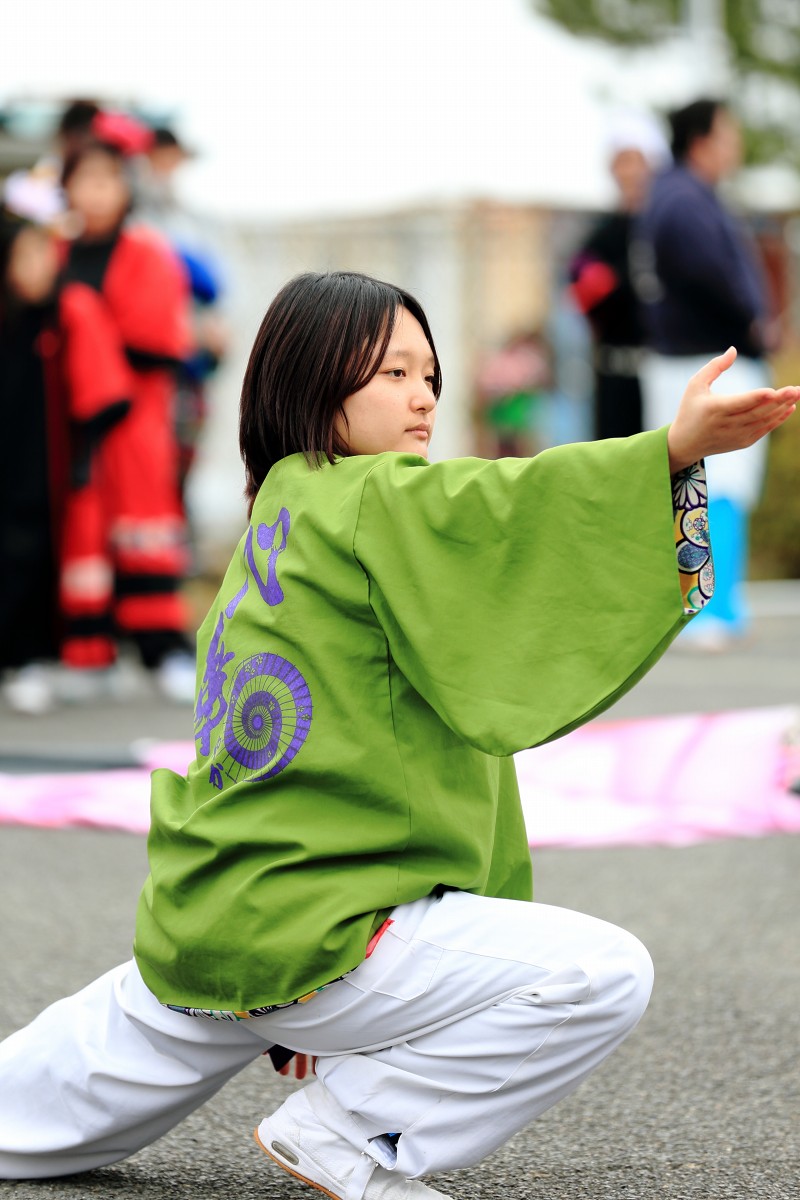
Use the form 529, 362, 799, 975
239, 271, 441, 509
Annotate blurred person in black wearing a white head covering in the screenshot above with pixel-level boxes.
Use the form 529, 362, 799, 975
570, 113, 669, 438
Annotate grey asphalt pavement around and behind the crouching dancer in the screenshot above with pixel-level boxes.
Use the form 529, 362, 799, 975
0, 586, 800, 1200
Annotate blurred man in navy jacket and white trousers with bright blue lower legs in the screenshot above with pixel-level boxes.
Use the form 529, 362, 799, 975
636, 100, 771, 649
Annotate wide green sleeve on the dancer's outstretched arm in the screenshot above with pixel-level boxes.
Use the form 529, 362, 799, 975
354, 430, 708, 755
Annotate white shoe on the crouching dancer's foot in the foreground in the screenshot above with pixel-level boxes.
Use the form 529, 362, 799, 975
254, 1080, 447, 1200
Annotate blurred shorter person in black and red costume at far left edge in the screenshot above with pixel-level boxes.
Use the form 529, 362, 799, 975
0, 208, 132, 715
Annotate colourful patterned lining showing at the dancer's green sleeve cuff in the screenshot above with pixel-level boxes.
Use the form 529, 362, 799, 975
672, 461, 714, 616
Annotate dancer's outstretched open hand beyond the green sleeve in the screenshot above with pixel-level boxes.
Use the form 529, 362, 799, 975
667, 347, 800, 475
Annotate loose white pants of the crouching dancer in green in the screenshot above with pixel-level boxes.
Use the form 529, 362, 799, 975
0, 893, 652, 1178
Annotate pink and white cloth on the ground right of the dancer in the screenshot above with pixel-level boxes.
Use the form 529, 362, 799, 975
517, 708, 800, 846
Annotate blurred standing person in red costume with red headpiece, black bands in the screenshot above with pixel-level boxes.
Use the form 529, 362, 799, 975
61, 112, 194, 702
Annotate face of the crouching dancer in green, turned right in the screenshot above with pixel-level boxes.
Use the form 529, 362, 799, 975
336, 308, 437, 458
